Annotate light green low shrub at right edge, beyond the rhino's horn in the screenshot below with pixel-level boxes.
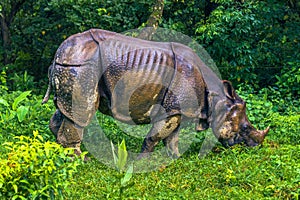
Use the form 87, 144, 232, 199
238, 81, 300, 144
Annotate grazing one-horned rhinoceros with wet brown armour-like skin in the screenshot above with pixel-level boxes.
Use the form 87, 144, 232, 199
43, 29, 269, 157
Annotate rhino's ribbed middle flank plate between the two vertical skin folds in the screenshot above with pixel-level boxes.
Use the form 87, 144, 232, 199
99, 35, 175, 124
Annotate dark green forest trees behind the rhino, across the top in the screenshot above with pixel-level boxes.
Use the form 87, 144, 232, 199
0, 0, 300, 92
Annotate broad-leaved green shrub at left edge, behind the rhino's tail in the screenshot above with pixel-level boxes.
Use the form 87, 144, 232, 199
0, 91, 54, 141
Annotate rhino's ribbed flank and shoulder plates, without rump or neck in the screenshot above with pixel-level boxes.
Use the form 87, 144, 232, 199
99, 34, 213, 123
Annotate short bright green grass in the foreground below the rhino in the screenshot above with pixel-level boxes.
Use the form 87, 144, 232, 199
66, 141, 300, 199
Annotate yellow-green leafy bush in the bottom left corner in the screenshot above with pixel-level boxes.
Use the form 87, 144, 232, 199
0, 131, 82, 199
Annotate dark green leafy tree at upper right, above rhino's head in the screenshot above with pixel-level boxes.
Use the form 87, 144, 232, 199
196, 0, 300, 87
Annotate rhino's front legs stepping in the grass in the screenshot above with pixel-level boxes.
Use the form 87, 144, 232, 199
138, 115, 181, 159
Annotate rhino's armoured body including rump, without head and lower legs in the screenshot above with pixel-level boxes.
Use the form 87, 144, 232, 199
52, 29, 225, 125
